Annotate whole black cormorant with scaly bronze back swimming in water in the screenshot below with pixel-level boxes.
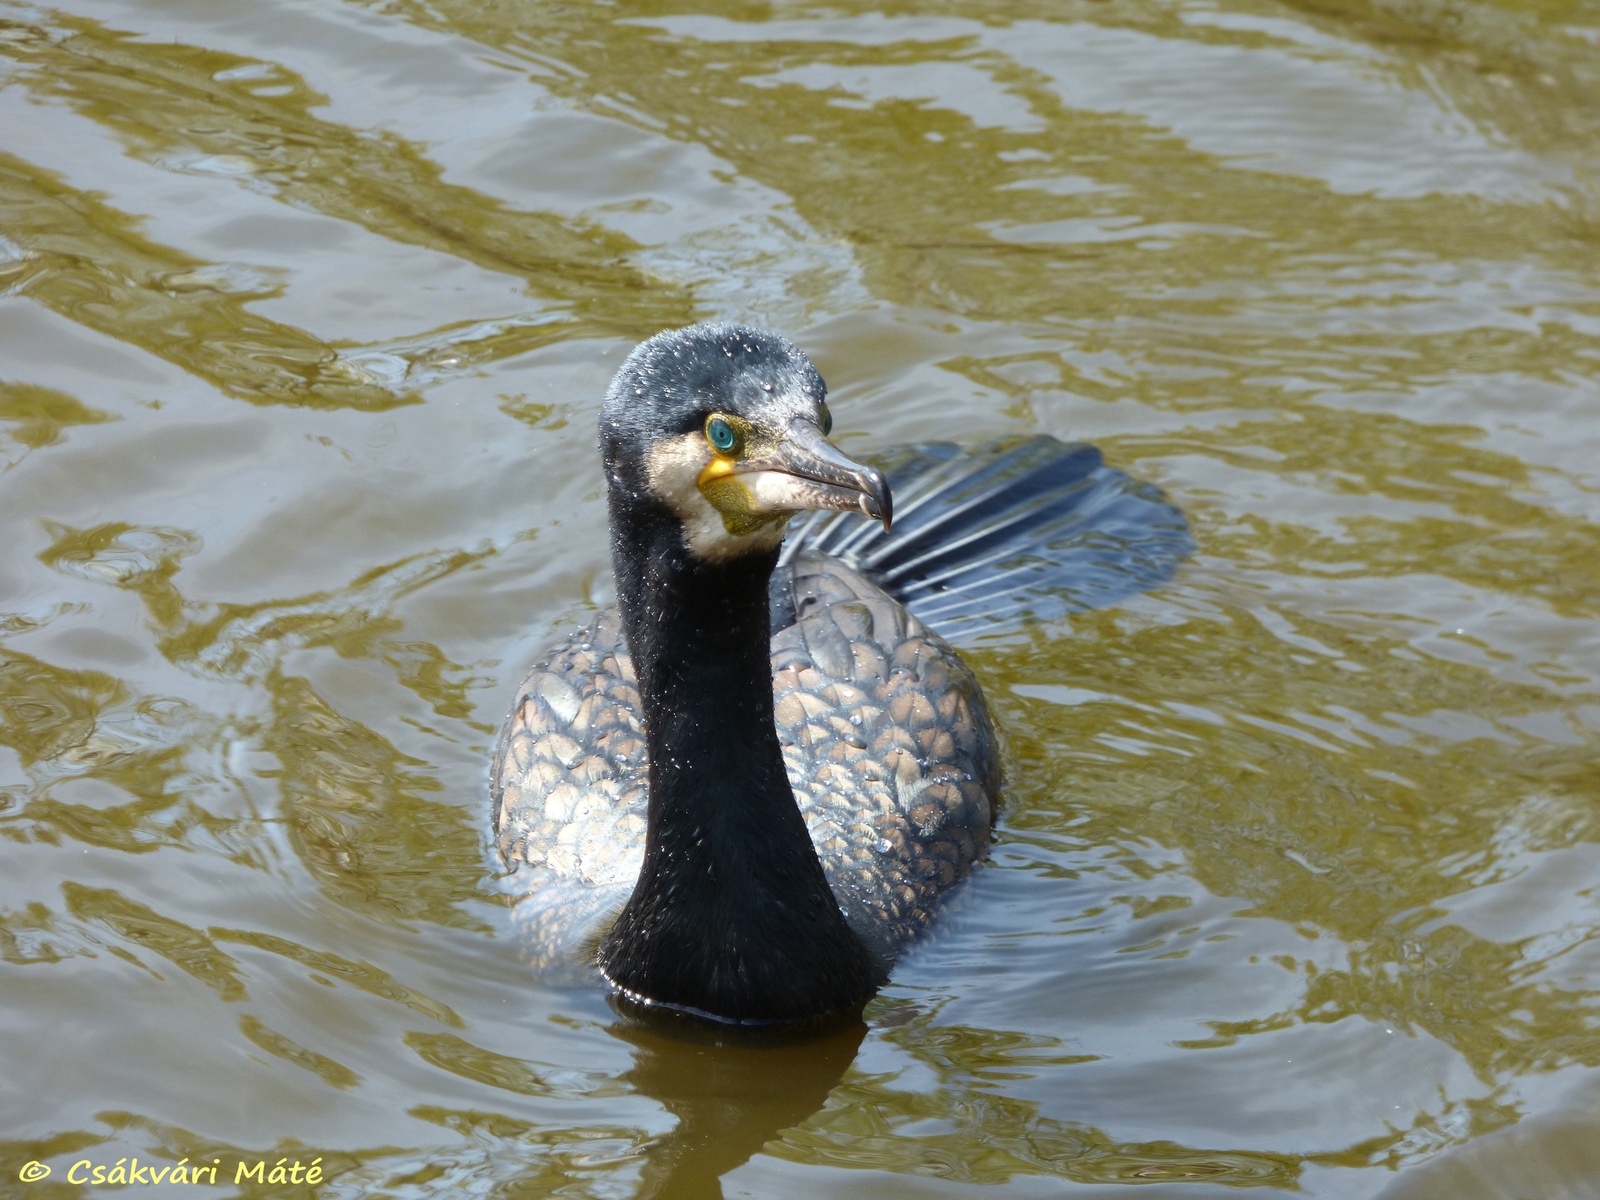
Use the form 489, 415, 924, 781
491, 323, 1189, 1024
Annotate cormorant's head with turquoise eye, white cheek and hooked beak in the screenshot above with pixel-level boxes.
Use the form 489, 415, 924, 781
600, 323, 891, 560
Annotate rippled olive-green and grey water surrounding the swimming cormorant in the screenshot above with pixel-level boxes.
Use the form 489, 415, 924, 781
0, 0, 1600, 1200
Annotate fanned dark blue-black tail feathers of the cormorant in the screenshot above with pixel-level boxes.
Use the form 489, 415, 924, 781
784, 435, 1194, 642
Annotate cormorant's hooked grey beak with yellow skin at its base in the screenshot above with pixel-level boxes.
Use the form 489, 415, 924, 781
696, 424, 894, 534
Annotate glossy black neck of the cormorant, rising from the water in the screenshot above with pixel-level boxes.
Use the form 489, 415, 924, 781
600, 494, 882, 1021
